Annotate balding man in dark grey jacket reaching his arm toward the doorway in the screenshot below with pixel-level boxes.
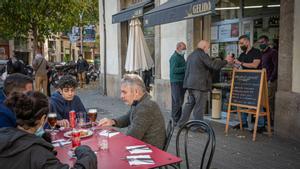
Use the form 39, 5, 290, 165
178, 40, 233, 127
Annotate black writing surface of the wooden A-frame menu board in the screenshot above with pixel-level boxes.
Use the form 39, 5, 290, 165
232, 72, 261, 107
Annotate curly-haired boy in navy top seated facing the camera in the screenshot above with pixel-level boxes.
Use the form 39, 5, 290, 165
50, 75, 85, 127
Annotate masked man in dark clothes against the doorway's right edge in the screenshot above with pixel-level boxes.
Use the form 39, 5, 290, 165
258, 35, 278, 125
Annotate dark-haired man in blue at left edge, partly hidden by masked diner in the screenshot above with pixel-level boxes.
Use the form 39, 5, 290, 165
0, 73, 33, 128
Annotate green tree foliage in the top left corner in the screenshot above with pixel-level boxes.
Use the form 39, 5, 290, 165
0, 0, 99, 45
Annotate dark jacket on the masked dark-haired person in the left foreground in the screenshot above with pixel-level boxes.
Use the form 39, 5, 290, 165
0, 128, 97, 169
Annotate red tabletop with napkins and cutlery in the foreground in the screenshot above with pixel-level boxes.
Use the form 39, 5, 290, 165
55, 129, 181, 169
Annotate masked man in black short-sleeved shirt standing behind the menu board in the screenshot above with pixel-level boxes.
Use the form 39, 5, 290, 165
235, 35, 265, 133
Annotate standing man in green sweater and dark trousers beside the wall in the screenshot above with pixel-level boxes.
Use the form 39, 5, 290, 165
169, 42, 186, 123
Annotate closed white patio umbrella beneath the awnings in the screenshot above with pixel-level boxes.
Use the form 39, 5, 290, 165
125, 18, 153, 72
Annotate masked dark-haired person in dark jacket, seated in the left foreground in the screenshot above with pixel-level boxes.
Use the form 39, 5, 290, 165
0, 92, 97, 169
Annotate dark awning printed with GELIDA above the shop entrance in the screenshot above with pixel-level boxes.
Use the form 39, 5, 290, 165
144, 0, 215, 27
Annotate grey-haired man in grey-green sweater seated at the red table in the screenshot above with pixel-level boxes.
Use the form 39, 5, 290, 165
99, 74, 166, 149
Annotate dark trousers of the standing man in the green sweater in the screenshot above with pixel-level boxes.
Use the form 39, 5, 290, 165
171, 82, 185, 123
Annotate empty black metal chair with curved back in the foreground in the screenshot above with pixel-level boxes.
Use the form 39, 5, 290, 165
171, 120, 216, 169
